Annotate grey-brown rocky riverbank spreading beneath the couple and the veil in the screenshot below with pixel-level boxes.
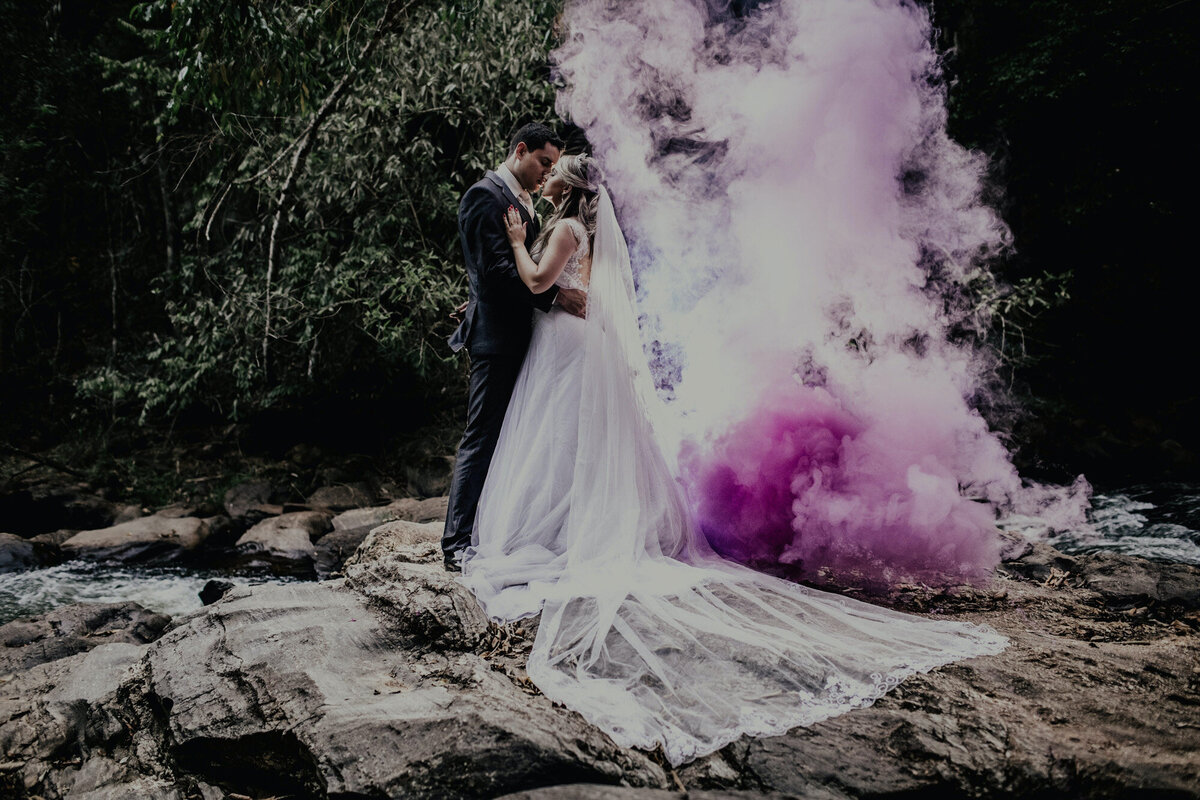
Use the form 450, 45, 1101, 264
0, 479, 1200, 800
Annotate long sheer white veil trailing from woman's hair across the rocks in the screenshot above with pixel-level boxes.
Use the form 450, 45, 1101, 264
477, 187, 1006, 764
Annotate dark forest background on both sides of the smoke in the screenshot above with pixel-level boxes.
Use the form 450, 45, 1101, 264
0, 0, 1200, 504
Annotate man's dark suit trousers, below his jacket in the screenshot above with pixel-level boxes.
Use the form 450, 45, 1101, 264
442, 355, 524, 558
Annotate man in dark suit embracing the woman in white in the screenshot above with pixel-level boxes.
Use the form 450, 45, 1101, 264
442, 122, 587, 572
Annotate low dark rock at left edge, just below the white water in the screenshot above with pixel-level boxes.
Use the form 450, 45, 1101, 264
0, 602, 170, 674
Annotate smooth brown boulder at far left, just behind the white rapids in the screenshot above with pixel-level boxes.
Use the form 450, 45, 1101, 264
62, 515, 210, 561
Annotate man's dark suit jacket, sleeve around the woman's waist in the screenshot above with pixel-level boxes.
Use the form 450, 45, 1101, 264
450, 170, 558, 357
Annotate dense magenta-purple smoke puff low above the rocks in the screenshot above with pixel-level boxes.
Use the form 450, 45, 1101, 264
682, 384, 1000, 585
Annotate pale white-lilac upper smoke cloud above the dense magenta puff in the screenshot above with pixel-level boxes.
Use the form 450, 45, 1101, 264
553, 0, 1086, 542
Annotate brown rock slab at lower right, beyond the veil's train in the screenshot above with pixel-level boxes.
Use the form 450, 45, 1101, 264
679, 561, 1200, 798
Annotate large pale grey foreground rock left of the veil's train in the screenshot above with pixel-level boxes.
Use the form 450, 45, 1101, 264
145, 575, 665, 798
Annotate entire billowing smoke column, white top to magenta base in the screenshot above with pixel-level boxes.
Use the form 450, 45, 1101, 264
554, 0, 1086, 583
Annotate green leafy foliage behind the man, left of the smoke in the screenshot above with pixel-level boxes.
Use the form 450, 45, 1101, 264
71, 0, 557, 421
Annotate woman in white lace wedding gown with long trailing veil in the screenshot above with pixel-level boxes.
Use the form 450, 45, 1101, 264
461, 156, 1007, 764
